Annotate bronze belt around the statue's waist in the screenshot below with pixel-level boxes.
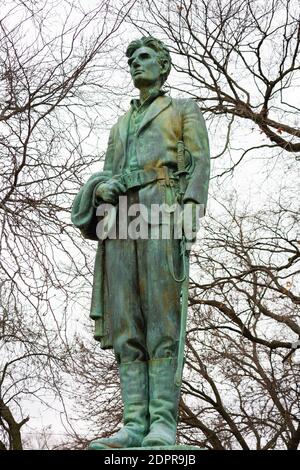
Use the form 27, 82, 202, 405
119, 166, 178, 190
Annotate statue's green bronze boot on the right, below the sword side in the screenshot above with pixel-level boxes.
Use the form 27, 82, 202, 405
142, 357, 180, 447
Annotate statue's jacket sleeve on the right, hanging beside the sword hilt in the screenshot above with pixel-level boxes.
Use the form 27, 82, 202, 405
183, 99, 210, 214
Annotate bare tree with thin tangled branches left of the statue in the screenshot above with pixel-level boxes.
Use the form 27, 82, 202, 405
0, 0, 134, 449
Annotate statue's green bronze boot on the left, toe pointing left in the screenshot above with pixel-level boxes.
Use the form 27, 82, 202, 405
89, 362, 149, 450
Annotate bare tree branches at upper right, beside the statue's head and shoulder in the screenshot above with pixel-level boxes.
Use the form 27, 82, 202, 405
130, 0, 300, 174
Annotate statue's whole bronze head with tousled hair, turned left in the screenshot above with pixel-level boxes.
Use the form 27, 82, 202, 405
126, 36, 171, 88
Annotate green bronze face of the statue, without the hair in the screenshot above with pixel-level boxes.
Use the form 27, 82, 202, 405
128, 47, 162, 88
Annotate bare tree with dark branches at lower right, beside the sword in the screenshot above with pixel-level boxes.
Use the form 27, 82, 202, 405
179, 182, 300, 450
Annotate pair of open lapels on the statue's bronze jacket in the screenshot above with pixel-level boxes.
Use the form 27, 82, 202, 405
119, 96, 172, 148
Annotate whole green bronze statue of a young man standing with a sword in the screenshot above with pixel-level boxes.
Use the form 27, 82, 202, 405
72, 37, 210, 449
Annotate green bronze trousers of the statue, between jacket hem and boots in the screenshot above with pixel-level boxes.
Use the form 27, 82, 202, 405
105, 217, 181, 364
